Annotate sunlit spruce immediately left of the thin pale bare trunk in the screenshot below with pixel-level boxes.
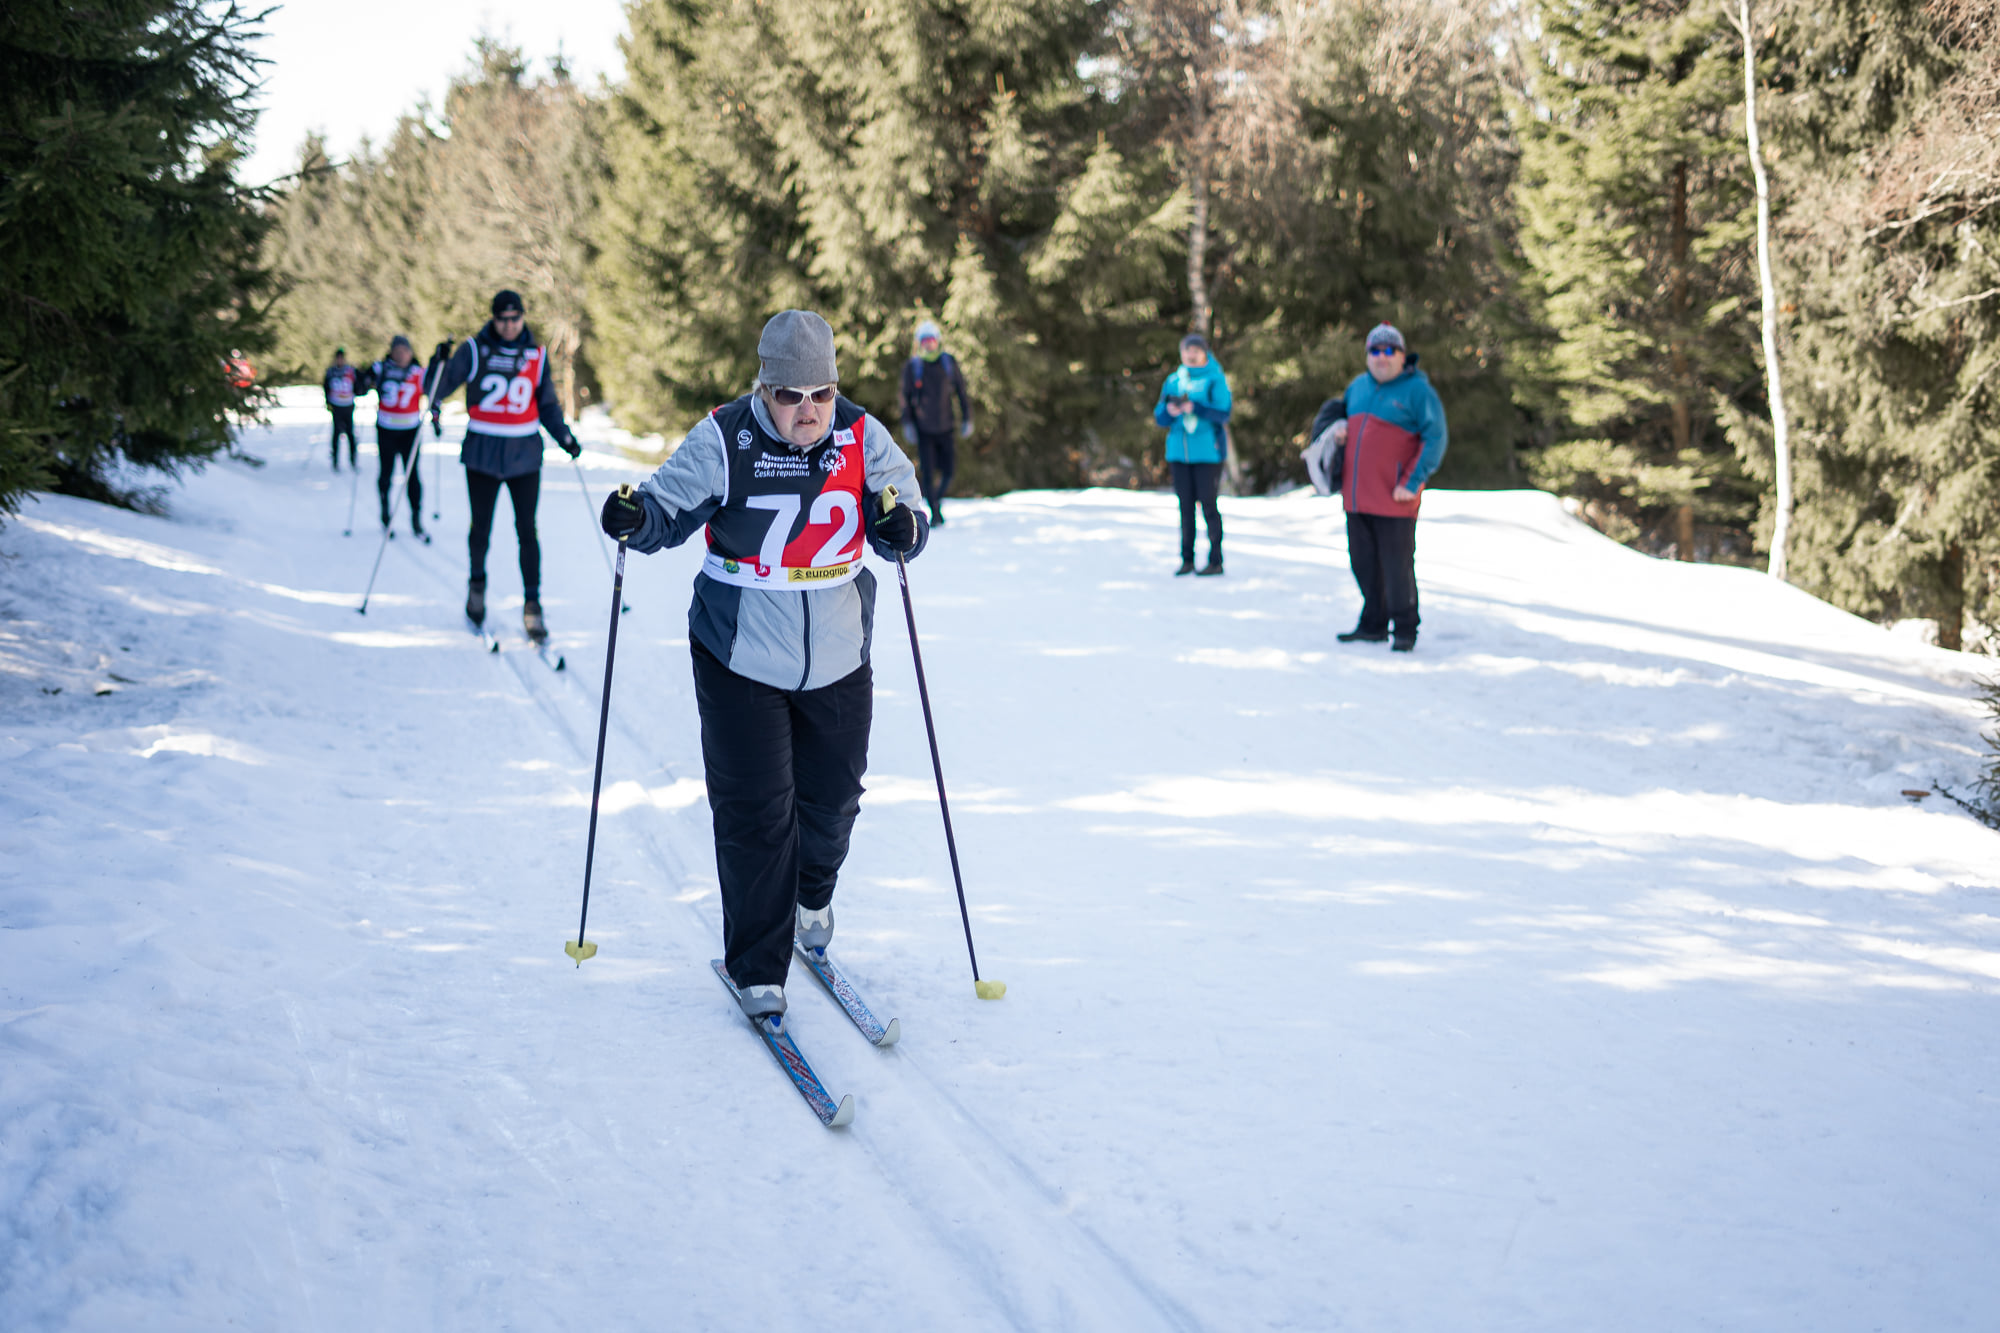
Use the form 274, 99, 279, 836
1514, 0, 1762, 560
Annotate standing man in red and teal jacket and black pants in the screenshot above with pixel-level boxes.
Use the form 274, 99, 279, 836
1308, 324, 1448, 652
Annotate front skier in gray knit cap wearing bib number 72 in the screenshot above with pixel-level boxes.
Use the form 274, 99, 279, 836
604, 310, 930, 1023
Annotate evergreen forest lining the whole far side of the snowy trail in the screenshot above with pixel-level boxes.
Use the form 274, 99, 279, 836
0, 0, 2000, 650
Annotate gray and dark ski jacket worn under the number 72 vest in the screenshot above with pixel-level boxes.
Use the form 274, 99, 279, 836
628, 394, 930, 691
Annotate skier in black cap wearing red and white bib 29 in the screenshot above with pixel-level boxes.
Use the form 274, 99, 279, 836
430, 290, 584, 642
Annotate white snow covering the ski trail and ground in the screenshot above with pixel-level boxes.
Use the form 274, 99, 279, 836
11, 406, 2000, 1331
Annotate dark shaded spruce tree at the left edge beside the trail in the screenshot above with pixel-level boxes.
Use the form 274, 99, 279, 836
0, 0, 266, 512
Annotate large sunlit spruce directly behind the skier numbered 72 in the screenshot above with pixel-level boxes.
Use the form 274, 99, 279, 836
592, 0, 1136, 488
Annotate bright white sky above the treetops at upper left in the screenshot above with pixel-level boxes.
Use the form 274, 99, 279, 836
240, 0, 626, 184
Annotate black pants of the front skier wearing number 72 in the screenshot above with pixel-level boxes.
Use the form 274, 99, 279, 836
694, 638, 874, 987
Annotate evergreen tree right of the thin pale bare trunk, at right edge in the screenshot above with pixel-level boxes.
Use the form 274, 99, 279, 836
1768, 0, 2000, 650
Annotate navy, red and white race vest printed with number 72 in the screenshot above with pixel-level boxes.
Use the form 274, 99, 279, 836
702, 396, 868, 592
